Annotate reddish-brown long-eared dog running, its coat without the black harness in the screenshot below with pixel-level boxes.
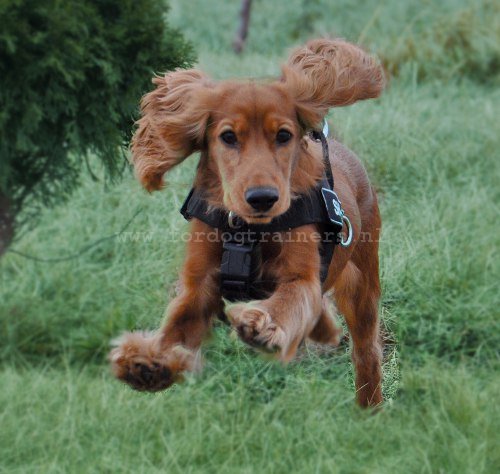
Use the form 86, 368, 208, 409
110, 39, 384, 406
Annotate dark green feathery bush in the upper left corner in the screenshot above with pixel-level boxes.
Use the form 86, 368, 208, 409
0, 0, 193, 254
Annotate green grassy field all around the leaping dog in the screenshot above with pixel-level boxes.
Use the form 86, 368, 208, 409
0, 0, 500, 474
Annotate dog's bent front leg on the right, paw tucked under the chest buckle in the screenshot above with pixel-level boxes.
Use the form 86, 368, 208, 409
227, 226, 322, 361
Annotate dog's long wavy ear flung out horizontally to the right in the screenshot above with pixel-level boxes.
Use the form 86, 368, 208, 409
282, 39, 385, 128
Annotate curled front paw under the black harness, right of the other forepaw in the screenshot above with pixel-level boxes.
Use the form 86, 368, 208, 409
227, 304, 286, 352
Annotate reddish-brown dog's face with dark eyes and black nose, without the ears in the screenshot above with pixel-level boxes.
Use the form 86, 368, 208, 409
205, 82, 303, 223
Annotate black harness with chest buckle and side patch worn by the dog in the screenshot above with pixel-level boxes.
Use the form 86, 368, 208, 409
181, 131, 344, 301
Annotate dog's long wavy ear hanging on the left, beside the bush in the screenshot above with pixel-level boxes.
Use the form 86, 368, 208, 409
131, 69, 212, 191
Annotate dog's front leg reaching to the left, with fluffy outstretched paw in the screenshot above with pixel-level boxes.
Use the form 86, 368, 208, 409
110, 220, 222, 391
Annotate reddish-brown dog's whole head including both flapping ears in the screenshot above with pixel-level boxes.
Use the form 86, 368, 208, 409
132, 39, 384, 223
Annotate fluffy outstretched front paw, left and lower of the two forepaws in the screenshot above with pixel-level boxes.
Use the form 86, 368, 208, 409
109, 332, 200, 392
